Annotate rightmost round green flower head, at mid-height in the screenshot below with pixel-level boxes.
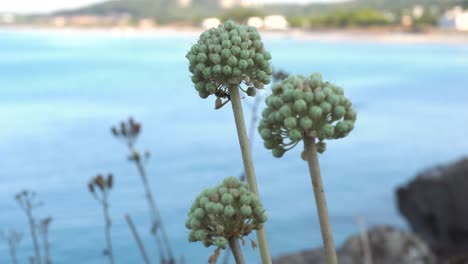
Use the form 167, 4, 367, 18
258, 73, 357, 158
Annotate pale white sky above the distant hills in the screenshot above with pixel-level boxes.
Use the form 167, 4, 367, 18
0, 0, 342, 13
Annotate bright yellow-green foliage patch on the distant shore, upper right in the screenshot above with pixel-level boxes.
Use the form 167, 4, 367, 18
309, 9, 392, 27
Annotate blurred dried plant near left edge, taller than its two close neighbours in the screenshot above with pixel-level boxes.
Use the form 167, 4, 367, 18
15, 190, 42, 264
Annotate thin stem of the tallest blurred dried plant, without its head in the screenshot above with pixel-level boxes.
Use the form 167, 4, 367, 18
132, 157, 175, 264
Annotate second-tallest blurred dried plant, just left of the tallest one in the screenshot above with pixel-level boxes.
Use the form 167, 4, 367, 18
88, 174, 114, 264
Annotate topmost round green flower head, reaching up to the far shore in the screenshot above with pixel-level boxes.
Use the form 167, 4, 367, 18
186, 20, 272, 98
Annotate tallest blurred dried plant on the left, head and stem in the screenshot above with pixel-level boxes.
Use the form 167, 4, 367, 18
111, 118, 176, 264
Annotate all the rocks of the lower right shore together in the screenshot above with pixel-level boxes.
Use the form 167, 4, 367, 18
273, 158, 468, 264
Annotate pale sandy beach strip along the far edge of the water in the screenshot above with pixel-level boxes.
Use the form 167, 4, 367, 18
0, 25, 468, 44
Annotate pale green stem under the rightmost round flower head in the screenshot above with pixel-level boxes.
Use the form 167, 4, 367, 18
304, 136, 337, 264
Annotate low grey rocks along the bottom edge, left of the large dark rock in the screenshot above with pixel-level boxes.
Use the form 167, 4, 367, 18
273, 226, 437, 264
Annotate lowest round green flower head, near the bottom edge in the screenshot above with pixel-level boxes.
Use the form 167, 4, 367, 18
185, 177, 267, 249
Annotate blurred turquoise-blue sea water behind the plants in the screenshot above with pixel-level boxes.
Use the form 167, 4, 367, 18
0, 30, 468, 263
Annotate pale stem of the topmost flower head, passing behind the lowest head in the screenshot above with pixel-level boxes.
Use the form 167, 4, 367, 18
229, 86, 271, 264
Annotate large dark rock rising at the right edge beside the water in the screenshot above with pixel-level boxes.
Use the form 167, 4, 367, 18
397, 159, 468, 256
